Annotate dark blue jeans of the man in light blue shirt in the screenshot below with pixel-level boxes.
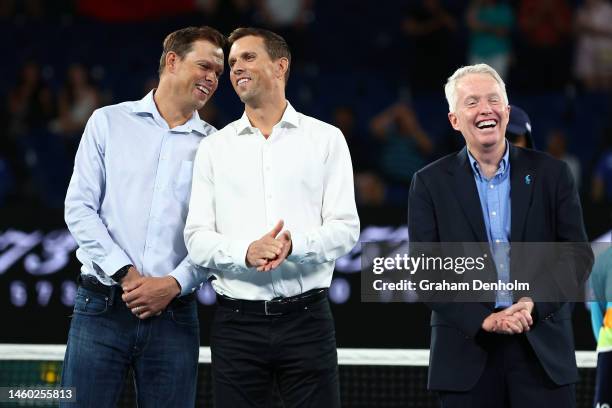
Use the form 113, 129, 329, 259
60, 287, 200, 408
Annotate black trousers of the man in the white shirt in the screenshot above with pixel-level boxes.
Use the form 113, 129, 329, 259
210, 298, 340, 408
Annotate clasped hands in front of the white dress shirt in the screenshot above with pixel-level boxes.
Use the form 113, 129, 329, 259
246, 220, 292, 272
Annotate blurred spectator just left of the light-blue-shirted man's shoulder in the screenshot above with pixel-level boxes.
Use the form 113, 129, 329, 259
51, 64, 101, 138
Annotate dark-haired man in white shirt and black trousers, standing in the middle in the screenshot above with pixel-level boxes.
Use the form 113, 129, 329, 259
185, 28, 359, 408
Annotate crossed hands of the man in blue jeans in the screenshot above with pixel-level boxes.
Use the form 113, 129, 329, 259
121, 276, 181, 319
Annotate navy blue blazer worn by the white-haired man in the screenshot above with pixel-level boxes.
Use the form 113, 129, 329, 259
408, 145, 593, 391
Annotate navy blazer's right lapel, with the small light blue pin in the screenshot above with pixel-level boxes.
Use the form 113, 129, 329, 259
510, 145, 536, 242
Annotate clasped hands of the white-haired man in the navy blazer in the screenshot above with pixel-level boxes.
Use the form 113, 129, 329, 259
482, 297, 534, 334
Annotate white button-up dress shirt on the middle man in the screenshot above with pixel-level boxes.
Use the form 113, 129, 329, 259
185, 103, 359, 300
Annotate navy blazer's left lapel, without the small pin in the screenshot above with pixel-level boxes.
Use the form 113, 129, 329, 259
451, 147, 488, 242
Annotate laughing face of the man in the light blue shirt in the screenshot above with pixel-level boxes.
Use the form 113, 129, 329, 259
166, 40, 223, 110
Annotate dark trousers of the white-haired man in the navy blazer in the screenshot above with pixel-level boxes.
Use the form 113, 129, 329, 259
439, 334, 576, 408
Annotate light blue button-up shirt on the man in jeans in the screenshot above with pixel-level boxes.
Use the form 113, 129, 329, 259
65, 91, 216, 295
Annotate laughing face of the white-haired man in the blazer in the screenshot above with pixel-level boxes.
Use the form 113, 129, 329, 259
448, 74, 510, 153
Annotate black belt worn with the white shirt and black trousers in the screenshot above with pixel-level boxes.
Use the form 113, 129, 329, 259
217, 288, 327, 316
